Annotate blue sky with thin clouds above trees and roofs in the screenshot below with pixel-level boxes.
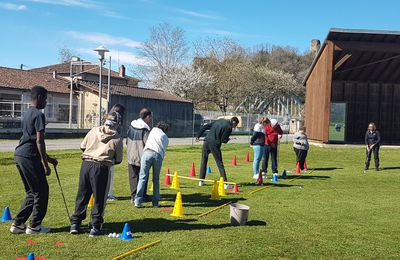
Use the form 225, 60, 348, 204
0, 0, 400, 71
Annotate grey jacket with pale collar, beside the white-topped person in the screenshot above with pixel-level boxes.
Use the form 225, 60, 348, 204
126, 118, 150, 166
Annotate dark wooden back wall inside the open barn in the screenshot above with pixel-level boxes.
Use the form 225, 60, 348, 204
331, 80, 400, 144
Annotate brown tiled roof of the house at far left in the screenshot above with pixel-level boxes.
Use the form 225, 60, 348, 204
0, 67, 69, 93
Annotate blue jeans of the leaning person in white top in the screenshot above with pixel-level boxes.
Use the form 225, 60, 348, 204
135, 150, 163, 206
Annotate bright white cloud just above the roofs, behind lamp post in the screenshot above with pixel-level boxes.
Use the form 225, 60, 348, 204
77, 49, 151, 66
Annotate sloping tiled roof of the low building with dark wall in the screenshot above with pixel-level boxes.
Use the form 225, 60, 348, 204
79, 80, 192, 103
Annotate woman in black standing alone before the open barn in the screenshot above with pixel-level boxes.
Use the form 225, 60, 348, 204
364, 122, 381, 171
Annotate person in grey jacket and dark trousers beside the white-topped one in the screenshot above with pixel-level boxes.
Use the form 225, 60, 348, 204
126, 108, 152, 203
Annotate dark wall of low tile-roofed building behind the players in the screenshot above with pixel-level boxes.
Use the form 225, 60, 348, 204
111, 95, 193, 137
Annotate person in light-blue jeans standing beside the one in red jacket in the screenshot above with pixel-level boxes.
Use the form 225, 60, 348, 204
250, 118, 271, 179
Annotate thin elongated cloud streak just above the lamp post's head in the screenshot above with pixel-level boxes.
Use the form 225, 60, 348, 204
67, 31, 142, 48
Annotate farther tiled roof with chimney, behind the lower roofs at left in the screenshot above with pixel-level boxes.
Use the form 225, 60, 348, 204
31, 62, 140, 82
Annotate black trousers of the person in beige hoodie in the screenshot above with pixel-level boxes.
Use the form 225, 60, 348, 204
71, 161, 109, 229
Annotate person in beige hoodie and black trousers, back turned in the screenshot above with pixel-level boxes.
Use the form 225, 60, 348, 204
70, 112, 123, 237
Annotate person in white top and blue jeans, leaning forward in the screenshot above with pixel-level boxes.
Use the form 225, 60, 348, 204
135, 121, 169, 208
